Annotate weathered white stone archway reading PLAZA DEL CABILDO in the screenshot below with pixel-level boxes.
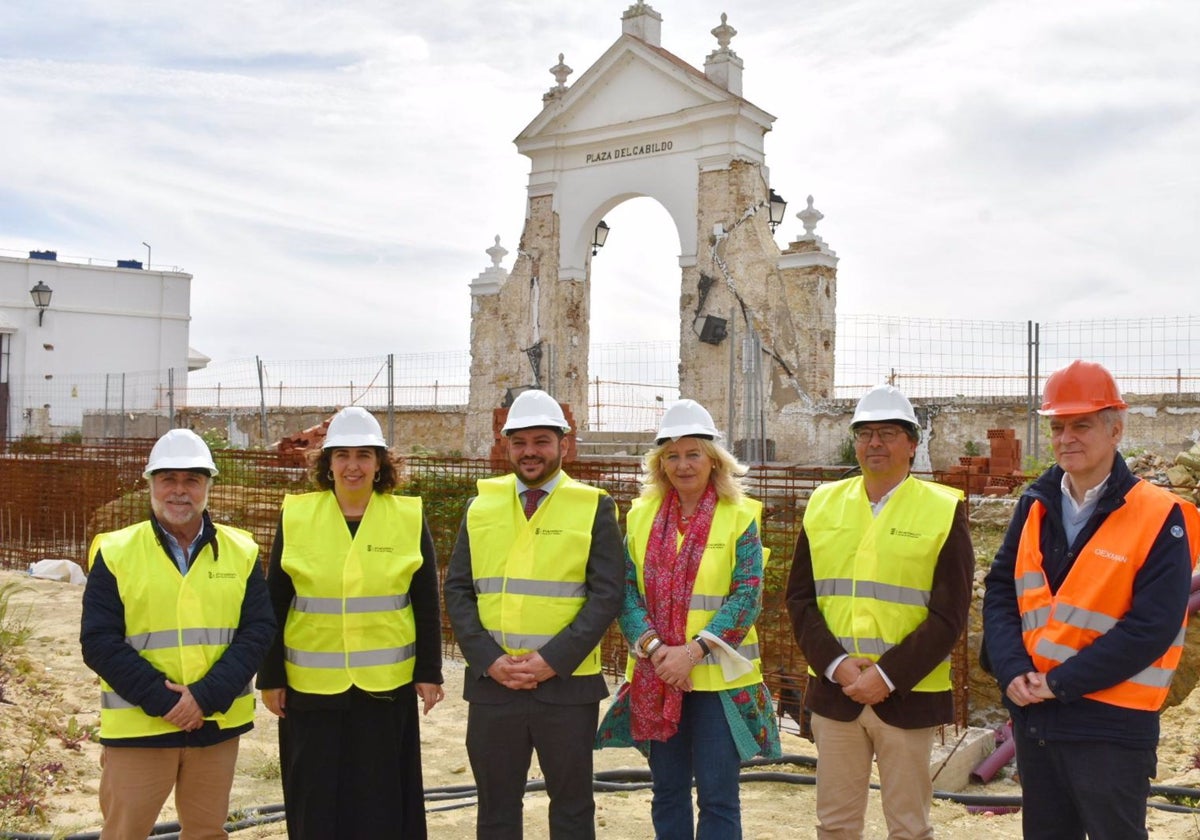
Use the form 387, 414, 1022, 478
466, 1, 836, 452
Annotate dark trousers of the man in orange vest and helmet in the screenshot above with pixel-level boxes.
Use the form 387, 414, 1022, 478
1013, 727, 1158, 840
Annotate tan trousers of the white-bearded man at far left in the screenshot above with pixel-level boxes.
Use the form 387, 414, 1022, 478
100, 738, 239, 840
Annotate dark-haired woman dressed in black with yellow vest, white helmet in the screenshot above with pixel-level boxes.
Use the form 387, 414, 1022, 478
258, 406, 444, 840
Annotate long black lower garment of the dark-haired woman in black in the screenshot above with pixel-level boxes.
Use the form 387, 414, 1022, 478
280, 686, 427, 840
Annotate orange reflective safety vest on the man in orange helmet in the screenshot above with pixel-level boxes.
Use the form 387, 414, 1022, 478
1014, 480, 1200, 712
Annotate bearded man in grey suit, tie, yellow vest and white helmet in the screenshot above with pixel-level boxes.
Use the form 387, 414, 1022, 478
444, 390, 625, 840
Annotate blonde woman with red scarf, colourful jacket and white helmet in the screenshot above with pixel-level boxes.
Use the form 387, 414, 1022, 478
595, 400, 780, 838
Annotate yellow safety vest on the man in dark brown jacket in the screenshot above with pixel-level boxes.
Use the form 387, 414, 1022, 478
804, 475, 962, 691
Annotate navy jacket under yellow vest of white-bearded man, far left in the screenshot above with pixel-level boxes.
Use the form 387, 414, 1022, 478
79, 511, 275, 746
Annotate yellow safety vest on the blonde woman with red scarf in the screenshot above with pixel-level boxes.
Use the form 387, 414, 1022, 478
625, 498, 770, 691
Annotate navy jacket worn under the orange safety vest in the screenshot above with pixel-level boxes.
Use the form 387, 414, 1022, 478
983, 452, 1192, 748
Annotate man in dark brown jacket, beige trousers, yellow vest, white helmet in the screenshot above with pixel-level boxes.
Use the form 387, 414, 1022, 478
787, 385, 974, 840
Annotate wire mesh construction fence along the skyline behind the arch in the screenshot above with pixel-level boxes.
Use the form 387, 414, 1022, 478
10, 316, 1200, 438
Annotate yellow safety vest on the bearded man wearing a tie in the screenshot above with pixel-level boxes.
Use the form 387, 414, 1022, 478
467, 473, 604, 677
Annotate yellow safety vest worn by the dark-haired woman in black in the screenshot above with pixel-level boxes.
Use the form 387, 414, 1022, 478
281, 491, 421, 695
